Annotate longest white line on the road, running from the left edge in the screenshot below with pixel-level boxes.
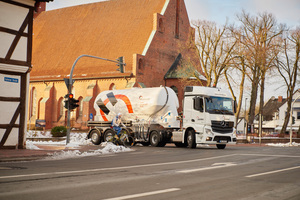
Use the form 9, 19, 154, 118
0, 154, 236, 179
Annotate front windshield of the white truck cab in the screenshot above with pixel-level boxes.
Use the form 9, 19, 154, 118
205, 97, 234, 115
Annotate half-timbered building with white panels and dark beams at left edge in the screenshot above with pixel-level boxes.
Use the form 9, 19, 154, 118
0, 0, 49, 148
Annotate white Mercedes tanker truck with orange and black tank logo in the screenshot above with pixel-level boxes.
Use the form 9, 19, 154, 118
87, 86, 236, 149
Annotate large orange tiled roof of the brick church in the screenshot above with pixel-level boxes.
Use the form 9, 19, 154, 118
31, 0, 167, 80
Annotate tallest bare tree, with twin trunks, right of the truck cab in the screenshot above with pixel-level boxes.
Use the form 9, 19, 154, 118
236, 11, 283, 124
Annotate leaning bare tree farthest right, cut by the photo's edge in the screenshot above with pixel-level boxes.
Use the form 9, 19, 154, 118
276, 27, 300, 136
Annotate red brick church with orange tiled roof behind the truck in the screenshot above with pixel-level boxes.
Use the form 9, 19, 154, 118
28, 0, 202, 129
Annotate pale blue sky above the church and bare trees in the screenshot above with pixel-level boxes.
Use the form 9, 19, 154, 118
46, 0, 300, 101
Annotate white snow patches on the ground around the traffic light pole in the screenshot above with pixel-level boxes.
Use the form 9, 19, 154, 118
26, 131, 132, 160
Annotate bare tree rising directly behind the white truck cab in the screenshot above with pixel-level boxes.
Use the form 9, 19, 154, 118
193, 20, 236, 87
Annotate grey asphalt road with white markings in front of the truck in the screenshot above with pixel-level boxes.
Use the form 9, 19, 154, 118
0, 145, 300, 200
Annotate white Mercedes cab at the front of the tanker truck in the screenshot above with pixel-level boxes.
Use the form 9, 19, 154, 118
182, 86, 236, 149
